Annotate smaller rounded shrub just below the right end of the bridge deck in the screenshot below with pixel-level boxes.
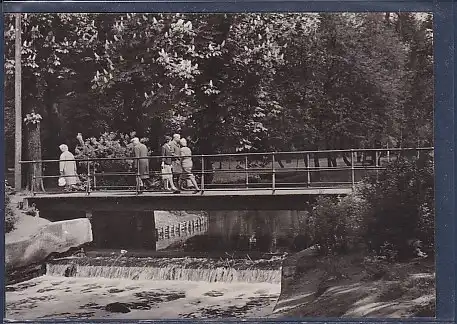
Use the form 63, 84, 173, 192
308, 196, 367, 255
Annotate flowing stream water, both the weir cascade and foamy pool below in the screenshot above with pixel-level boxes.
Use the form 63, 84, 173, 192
6, 256, 282, 320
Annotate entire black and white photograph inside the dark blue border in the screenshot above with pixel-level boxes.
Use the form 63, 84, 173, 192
4, 12, 438, 321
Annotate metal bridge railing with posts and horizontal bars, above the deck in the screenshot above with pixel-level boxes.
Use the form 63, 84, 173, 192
21, 147, 433, 194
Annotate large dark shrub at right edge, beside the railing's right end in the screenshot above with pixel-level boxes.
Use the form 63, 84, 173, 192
361, 156, 434, 259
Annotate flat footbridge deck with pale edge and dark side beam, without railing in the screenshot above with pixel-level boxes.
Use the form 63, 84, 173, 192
25, 188, 352, 212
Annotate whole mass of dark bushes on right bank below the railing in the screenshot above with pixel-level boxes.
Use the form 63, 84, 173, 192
306, 155, 435, 259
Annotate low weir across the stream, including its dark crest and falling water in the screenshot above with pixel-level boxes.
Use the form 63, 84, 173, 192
46, 257, 282, 285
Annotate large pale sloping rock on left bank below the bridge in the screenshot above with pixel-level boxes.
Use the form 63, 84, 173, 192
5, 218, 93, 269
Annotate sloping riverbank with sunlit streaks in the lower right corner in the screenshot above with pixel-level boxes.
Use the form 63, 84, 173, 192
273, 251, 436, 319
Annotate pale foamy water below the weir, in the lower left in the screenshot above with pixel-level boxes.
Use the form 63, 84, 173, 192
6, 276, 280, 320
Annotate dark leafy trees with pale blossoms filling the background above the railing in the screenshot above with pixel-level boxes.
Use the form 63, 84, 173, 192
4, 13, 433, 167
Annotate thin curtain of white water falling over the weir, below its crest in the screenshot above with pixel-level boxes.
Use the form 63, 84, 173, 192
46, 263, 281, 284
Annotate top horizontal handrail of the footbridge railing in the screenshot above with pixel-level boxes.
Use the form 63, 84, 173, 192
19, 147, 434, 164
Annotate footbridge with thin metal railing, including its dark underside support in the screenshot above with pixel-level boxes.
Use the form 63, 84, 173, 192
18, 148, 433, 249
